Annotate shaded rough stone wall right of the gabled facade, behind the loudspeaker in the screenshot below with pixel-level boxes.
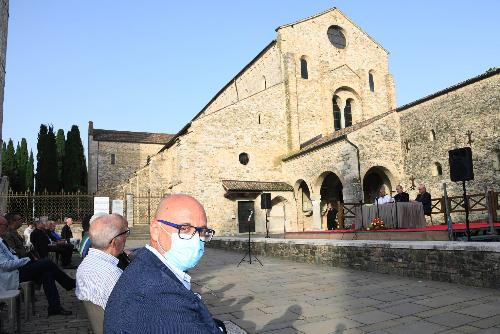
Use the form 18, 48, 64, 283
398, 71, 500, 218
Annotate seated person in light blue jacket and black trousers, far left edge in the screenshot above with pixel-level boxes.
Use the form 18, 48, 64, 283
0, 217, 75, 316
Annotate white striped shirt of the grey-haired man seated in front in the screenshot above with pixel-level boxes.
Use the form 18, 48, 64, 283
75, 248, 123, 309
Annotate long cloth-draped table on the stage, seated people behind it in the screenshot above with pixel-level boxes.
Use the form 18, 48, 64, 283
354, 202, 425, 229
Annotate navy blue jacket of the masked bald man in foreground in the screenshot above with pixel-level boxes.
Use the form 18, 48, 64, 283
104, 248, 221, 334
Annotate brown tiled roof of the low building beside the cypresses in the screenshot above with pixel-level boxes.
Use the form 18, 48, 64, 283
89, 129, 173, 145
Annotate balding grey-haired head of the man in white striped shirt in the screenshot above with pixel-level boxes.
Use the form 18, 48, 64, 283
89, 214, 127, 250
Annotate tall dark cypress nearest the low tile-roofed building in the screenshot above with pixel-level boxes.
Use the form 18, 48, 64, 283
63, 125, 87, 192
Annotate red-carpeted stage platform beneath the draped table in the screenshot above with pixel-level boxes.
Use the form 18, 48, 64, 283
285, 222, 500, 241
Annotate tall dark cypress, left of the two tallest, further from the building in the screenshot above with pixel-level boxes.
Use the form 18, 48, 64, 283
35, 124, 60, 192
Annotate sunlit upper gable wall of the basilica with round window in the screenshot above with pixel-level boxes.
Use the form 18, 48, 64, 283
277, 9, 396, 149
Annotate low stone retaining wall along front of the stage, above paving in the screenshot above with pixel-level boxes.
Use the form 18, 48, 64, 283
207, 238, 500, 289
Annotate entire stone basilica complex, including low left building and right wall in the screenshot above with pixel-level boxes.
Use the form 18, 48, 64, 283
88, 8, 500, 235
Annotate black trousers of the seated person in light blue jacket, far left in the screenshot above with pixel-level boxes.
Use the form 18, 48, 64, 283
19, 259, 76, 311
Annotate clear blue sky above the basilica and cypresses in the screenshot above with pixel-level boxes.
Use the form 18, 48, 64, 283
3, 0, 500, 158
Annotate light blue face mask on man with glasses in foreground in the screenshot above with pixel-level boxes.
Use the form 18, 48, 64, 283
157, 225, 205, 271
